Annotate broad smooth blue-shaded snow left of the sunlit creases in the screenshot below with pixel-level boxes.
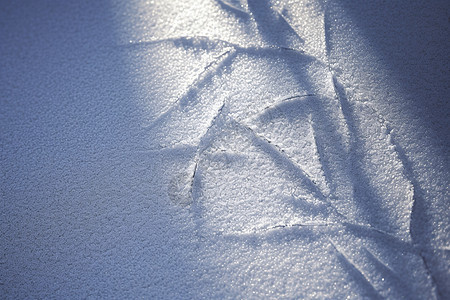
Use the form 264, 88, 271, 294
0, 0, 199, 299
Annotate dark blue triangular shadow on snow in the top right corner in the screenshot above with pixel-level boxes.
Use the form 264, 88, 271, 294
330, 0, 450, 150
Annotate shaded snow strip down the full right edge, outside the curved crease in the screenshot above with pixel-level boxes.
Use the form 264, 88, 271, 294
326, 0, 450, 298
